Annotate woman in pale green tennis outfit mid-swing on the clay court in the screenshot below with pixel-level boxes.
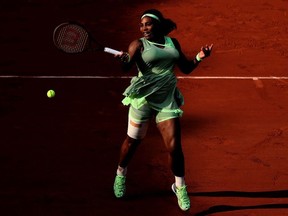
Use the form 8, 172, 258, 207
114, 9, 213, 211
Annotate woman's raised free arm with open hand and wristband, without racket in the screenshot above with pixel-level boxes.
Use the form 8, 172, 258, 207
172, 38, 213, 74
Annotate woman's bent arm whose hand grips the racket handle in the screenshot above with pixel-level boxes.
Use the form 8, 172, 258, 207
117, 40, 143, 71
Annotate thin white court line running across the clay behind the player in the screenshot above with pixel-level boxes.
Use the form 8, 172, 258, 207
0, 75, 288, 80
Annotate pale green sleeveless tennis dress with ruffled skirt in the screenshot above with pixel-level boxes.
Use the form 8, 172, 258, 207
122, 36, 184, 115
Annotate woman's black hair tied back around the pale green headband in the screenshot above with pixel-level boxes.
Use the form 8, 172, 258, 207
142, 9, 177, 35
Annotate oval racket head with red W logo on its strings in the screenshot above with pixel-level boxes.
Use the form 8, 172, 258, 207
53, 22, 92, 53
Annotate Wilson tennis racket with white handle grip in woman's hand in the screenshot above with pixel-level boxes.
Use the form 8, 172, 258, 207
53, 22, 122, 55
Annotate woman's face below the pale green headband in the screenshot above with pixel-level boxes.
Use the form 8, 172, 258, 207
140, 17, 158, 40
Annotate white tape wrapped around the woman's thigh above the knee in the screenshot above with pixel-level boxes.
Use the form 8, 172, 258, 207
127, 118, 149, 139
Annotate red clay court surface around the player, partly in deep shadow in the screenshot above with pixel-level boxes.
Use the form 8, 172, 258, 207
0, 0, 288, 216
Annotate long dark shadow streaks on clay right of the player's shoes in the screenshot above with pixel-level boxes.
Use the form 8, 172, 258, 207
189, 190, 288, 216
